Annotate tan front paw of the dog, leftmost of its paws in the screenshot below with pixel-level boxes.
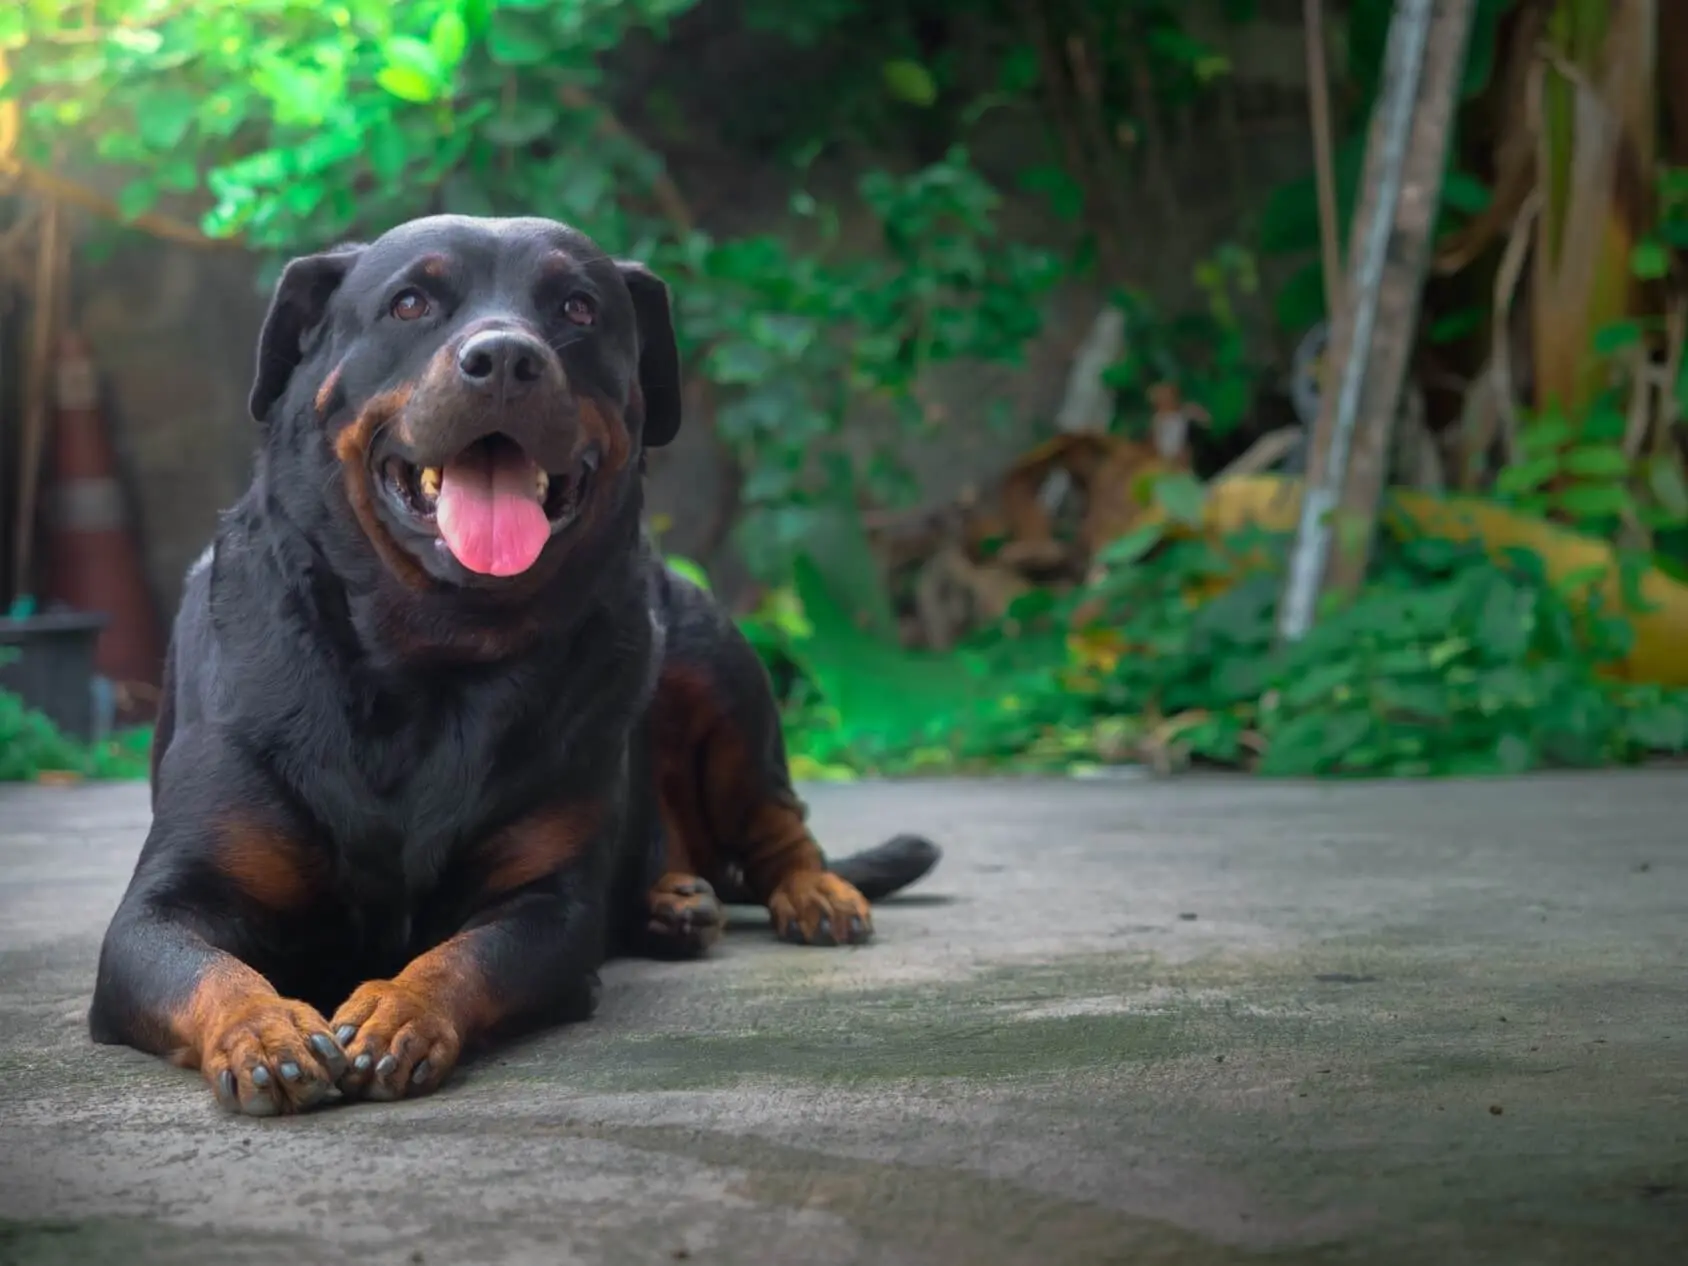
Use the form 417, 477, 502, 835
199, 994, 346, 1116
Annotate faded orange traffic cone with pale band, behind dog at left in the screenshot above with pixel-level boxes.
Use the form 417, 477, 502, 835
46, 331, 164, 715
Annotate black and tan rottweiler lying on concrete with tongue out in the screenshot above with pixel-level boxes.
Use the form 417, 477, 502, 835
89, 216, 937, 1116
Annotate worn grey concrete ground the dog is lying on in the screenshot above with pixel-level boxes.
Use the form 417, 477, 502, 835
0, 771, 1688, 1266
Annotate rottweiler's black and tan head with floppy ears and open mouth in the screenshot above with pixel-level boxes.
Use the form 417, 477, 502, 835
252, 216, 680, 592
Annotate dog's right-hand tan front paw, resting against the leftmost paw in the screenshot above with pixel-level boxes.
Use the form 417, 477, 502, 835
334, 981, 463, 1101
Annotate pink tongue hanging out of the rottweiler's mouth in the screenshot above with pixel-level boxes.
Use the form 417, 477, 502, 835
434, 442, 550, 576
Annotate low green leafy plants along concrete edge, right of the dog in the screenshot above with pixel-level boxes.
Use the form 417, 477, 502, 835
759, 516, 1688, 776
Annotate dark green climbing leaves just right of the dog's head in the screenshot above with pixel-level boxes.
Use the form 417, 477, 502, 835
680, 147, 1058, 577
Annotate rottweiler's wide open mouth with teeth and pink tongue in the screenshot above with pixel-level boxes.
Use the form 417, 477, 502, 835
380, 436, 598, 576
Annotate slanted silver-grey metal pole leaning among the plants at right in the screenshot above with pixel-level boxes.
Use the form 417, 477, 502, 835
1278, 0, 1435, 641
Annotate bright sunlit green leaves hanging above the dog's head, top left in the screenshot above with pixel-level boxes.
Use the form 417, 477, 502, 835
17, 0, 692, 252
